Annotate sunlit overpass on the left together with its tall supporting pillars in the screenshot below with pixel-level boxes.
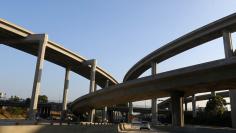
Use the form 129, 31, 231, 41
0, 19, 118, 119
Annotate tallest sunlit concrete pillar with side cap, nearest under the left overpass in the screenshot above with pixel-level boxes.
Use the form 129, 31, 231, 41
29, 34, 48, 120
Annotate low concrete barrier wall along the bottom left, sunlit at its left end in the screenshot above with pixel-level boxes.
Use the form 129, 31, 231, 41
0, 125, 118, 133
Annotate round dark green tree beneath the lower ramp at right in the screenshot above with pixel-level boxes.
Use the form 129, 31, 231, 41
205, 95, 227, 116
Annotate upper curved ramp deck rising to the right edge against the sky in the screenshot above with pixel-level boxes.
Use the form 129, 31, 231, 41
124, 13, 236, 82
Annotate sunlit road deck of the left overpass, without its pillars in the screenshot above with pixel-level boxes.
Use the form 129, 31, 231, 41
0, 18, 118, 88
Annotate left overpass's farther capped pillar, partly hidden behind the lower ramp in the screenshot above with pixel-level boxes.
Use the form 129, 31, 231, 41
89, 59, 97, 122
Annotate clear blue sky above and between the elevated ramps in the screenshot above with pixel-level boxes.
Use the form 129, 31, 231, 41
0, 0, 236, 106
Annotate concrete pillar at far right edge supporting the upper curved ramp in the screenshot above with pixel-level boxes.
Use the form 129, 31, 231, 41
223, 31, 236, 128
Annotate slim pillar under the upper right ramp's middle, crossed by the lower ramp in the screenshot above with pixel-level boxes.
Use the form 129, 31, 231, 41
151, 62, 158, 124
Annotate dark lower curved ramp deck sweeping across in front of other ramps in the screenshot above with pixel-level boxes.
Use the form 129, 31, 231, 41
71, 57, 236, 113
